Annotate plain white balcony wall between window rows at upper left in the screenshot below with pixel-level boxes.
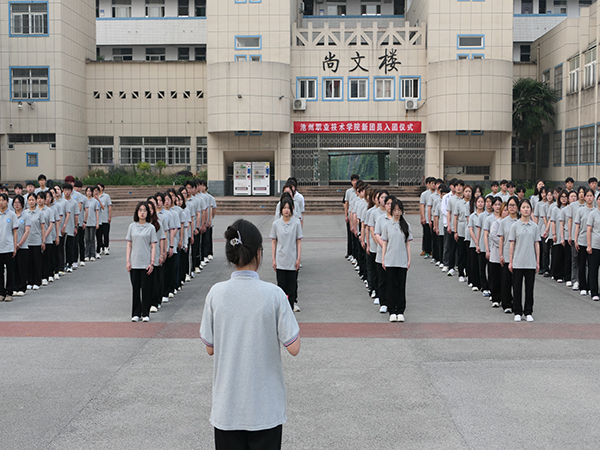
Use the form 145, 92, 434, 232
96, 17, 206, 46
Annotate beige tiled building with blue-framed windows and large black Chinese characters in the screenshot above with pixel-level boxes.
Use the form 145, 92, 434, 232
0, 0, 597, 195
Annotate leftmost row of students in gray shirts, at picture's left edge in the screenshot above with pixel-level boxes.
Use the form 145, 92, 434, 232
0, 183, 111, 302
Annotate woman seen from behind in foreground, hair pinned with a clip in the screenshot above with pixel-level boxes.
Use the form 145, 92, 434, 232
200, 219, 300, 449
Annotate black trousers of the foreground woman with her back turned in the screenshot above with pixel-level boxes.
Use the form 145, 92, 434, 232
215, 425, 283, 450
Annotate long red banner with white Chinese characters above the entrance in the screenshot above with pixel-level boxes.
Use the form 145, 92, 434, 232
294, 120, 421, 133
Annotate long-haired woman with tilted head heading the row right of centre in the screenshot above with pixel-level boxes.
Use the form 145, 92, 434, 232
381, 199, 413, 322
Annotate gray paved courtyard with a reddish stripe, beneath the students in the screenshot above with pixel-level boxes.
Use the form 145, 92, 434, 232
0, 216, 600, 450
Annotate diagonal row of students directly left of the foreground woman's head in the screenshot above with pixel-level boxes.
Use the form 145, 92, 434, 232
125, 180, 216, 322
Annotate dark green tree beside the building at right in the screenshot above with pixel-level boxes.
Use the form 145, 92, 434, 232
513, 78, 558, 178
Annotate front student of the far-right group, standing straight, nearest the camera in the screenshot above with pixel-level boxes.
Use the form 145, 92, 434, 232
508, 199, 540, 322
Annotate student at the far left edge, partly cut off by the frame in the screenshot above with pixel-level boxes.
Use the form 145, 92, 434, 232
0, 192, 19, 302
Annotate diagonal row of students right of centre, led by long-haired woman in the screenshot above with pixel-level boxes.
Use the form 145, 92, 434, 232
344, 175, 413, 322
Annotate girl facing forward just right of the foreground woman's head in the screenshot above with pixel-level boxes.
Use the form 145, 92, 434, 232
269, 194, 302, 310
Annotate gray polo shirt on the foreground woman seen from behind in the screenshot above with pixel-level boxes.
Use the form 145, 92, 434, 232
200, 271, 300, 431
